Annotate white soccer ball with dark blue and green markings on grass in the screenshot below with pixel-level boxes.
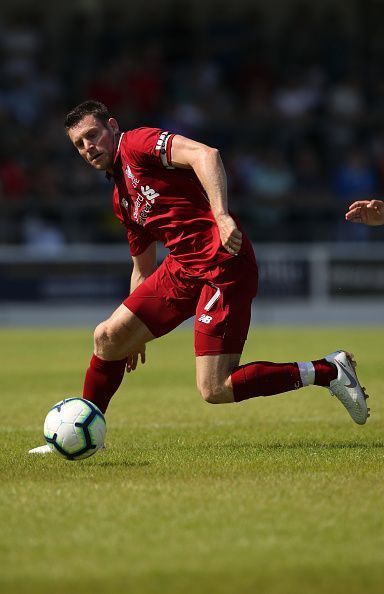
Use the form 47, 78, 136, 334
44, 398, 107, 460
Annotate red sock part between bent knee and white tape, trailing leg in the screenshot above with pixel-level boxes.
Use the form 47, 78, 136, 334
231, 361, 303, 402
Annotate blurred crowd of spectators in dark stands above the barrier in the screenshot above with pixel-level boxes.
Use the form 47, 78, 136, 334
0, 0, 384, 246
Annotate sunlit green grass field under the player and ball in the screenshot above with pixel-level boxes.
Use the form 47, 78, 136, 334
0, 327, 384, 594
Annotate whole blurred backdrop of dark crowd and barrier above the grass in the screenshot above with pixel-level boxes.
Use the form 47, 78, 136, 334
0, 0, 384, 325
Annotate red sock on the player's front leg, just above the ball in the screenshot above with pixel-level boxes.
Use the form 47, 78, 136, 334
83, 355, 127, 413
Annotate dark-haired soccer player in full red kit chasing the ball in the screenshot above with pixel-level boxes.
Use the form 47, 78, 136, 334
32, 101, 368, 453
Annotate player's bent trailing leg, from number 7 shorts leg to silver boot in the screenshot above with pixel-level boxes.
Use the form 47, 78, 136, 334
195, 260, 368, 424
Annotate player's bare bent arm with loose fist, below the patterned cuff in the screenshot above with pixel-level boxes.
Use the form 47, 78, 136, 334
171, 134, 242, 254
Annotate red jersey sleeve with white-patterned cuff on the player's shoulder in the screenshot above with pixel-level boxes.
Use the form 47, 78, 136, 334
122, 128, 175, 169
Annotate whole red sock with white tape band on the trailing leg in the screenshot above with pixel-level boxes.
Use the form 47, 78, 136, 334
231, 359, 337, 402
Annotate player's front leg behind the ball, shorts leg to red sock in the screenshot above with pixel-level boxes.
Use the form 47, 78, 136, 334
83, 258, 197, 412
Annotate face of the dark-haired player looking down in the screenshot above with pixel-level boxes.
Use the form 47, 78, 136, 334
68, 115, 119, 171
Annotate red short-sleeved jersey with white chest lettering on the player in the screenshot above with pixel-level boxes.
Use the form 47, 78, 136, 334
113, 128, 253, 271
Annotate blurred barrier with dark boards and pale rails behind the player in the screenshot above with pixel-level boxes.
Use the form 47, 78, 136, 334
0, 242, 384, 326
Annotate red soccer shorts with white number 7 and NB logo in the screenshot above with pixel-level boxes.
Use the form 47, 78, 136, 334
124, 254, 258, 356
